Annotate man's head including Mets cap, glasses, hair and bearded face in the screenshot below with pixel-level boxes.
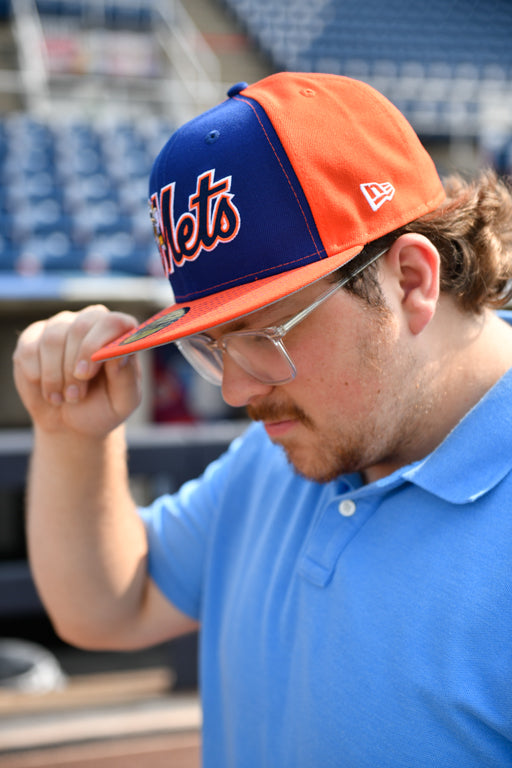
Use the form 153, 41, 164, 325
89, 73, 510, 481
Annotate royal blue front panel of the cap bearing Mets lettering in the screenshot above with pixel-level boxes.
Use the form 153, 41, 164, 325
150, 95, 326, 302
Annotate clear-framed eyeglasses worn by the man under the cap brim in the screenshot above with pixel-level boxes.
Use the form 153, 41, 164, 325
175, 249, 387, 386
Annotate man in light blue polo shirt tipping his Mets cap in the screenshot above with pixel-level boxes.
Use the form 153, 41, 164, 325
14, 73, 512, 768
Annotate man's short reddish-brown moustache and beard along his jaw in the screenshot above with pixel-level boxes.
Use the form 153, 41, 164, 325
246, 341, 428, 483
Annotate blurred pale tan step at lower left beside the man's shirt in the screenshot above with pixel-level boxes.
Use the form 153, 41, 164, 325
0, 668, 201, 756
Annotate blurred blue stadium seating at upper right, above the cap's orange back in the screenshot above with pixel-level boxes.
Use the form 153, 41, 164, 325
224, 0, 512, 162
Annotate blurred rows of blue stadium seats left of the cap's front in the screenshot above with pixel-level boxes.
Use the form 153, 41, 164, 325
0, 114, 173, 275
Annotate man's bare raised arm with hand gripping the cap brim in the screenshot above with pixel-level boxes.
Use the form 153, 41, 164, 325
13, 305, 195, 649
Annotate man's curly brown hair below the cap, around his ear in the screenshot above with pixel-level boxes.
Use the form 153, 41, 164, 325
342, 170, 512, 314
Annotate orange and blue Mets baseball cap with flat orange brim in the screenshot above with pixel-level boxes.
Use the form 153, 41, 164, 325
94, 72, 445, 360
